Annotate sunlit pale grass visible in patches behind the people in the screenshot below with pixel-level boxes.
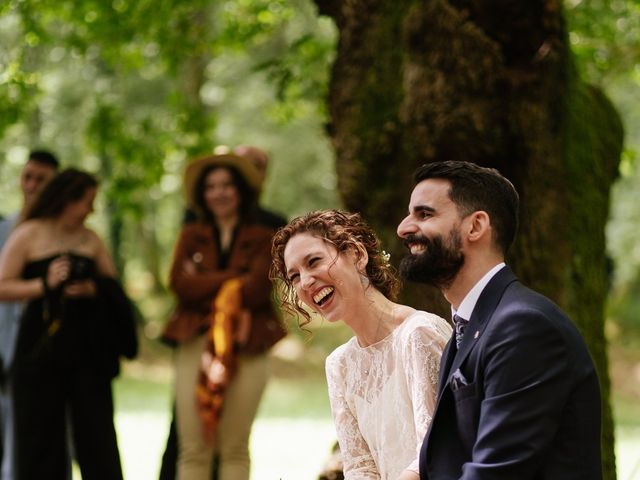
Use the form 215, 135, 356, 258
74, 325, 640, 480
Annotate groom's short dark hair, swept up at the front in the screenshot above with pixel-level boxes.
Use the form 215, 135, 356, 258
413, 160, 519, 255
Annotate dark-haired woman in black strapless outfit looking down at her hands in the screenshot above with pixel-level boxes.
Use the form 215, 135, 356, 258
0, 169, 136, 480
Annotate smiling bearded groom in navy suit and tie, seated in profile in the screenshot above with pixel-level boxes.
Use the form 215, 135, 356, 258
398, 161, 602, 480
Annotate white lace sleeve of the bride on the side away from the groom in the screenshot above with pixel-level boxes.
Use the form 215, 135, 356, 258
325, 350, 380, 480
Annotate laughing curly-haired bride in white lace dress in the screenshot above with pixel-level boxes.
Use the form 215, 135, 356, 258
272, 210, 451, 480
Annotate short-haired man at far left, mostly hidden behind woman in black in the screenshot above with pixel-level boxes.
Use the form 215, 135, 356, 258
0, 150, 59, 480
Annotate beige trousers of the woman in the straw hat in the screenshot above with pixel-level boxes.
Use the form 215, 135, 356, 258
175, 335, 269, 480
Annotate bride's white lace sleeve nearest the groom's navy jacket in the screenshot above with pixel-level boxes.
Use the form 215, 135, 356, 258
403, 315, 451, 473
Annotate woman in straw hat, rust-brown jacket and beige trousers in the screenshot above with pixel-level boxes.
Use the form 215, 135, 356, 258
163, 154, 284, 480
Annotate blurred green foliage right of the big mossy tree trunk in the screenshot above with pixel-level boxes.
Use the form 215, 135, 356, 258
565, 0, 640, 342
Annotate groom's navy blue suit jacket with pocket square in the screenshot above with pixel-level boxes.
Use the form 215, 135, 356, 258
420, 267, 602, 480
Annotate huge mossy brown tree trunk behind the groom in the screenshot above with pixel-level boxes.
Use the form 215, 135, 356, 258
316, 0, 622, 480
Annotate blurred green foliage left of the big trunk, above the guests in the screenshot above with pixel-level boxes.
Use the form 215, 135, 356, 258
0, 0, 337, 321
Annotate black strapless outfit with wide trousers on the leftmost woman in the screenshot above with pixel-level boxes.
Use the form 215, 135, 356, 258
11, 255, 122, 480
